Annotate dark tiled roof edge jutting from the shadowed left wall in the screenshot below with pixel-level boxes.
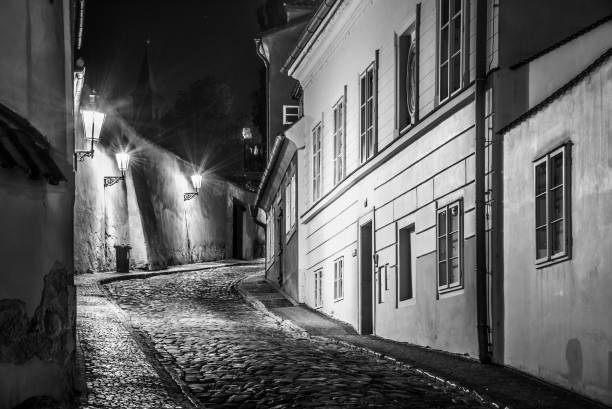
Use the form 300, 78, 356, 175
0, 103, 66, 185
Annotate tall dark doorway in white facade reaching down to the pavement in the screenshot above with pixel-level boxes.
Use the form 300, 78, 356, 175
359, 221, 374, 335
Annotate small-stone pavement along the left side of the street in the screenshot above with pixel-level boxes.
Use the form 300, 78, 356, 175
75, 261, 241, 409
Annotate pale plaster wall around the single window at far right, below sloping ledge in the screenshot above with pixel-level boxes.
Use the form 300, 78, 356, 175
503, 55, 612, 405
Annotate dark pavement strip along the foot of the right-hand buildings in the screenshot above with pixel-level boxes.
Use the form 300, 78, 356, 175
239, 274, 606, 409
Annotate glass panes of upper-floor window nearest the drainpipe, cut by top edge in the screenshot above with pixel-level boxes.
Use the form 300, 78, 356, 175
438, 0, 463, 102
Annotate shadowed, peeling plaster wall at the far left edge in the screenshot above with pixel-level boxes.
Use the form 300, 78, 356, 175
0, 0, 75, 409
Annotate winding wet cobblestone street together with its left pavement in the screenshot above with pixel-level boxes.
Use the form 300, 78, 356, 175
79, 265, 492, 408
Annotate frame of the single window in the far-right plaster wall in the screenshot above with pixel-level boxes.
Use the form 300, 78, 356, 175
533, 143, 572, 267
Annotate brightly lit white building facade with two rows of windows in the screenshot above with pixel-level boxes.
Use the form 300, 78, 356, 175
285, 0, 490, 356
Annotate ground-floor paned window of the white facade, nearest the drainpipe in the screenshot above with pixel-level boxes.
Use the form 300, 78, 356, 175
437, 202, 463, 293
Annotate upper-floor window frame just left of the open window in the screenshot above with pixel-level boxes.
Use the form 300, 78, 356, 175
358, 50, 379, 164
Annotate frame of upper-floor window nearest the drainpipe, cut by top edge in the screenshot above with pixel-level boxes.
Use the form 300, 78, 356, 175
436, 0, 468, 104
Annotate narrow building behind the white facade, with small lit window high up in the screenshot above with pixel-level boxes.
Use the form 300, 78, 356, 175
255, 2, 317, 299
